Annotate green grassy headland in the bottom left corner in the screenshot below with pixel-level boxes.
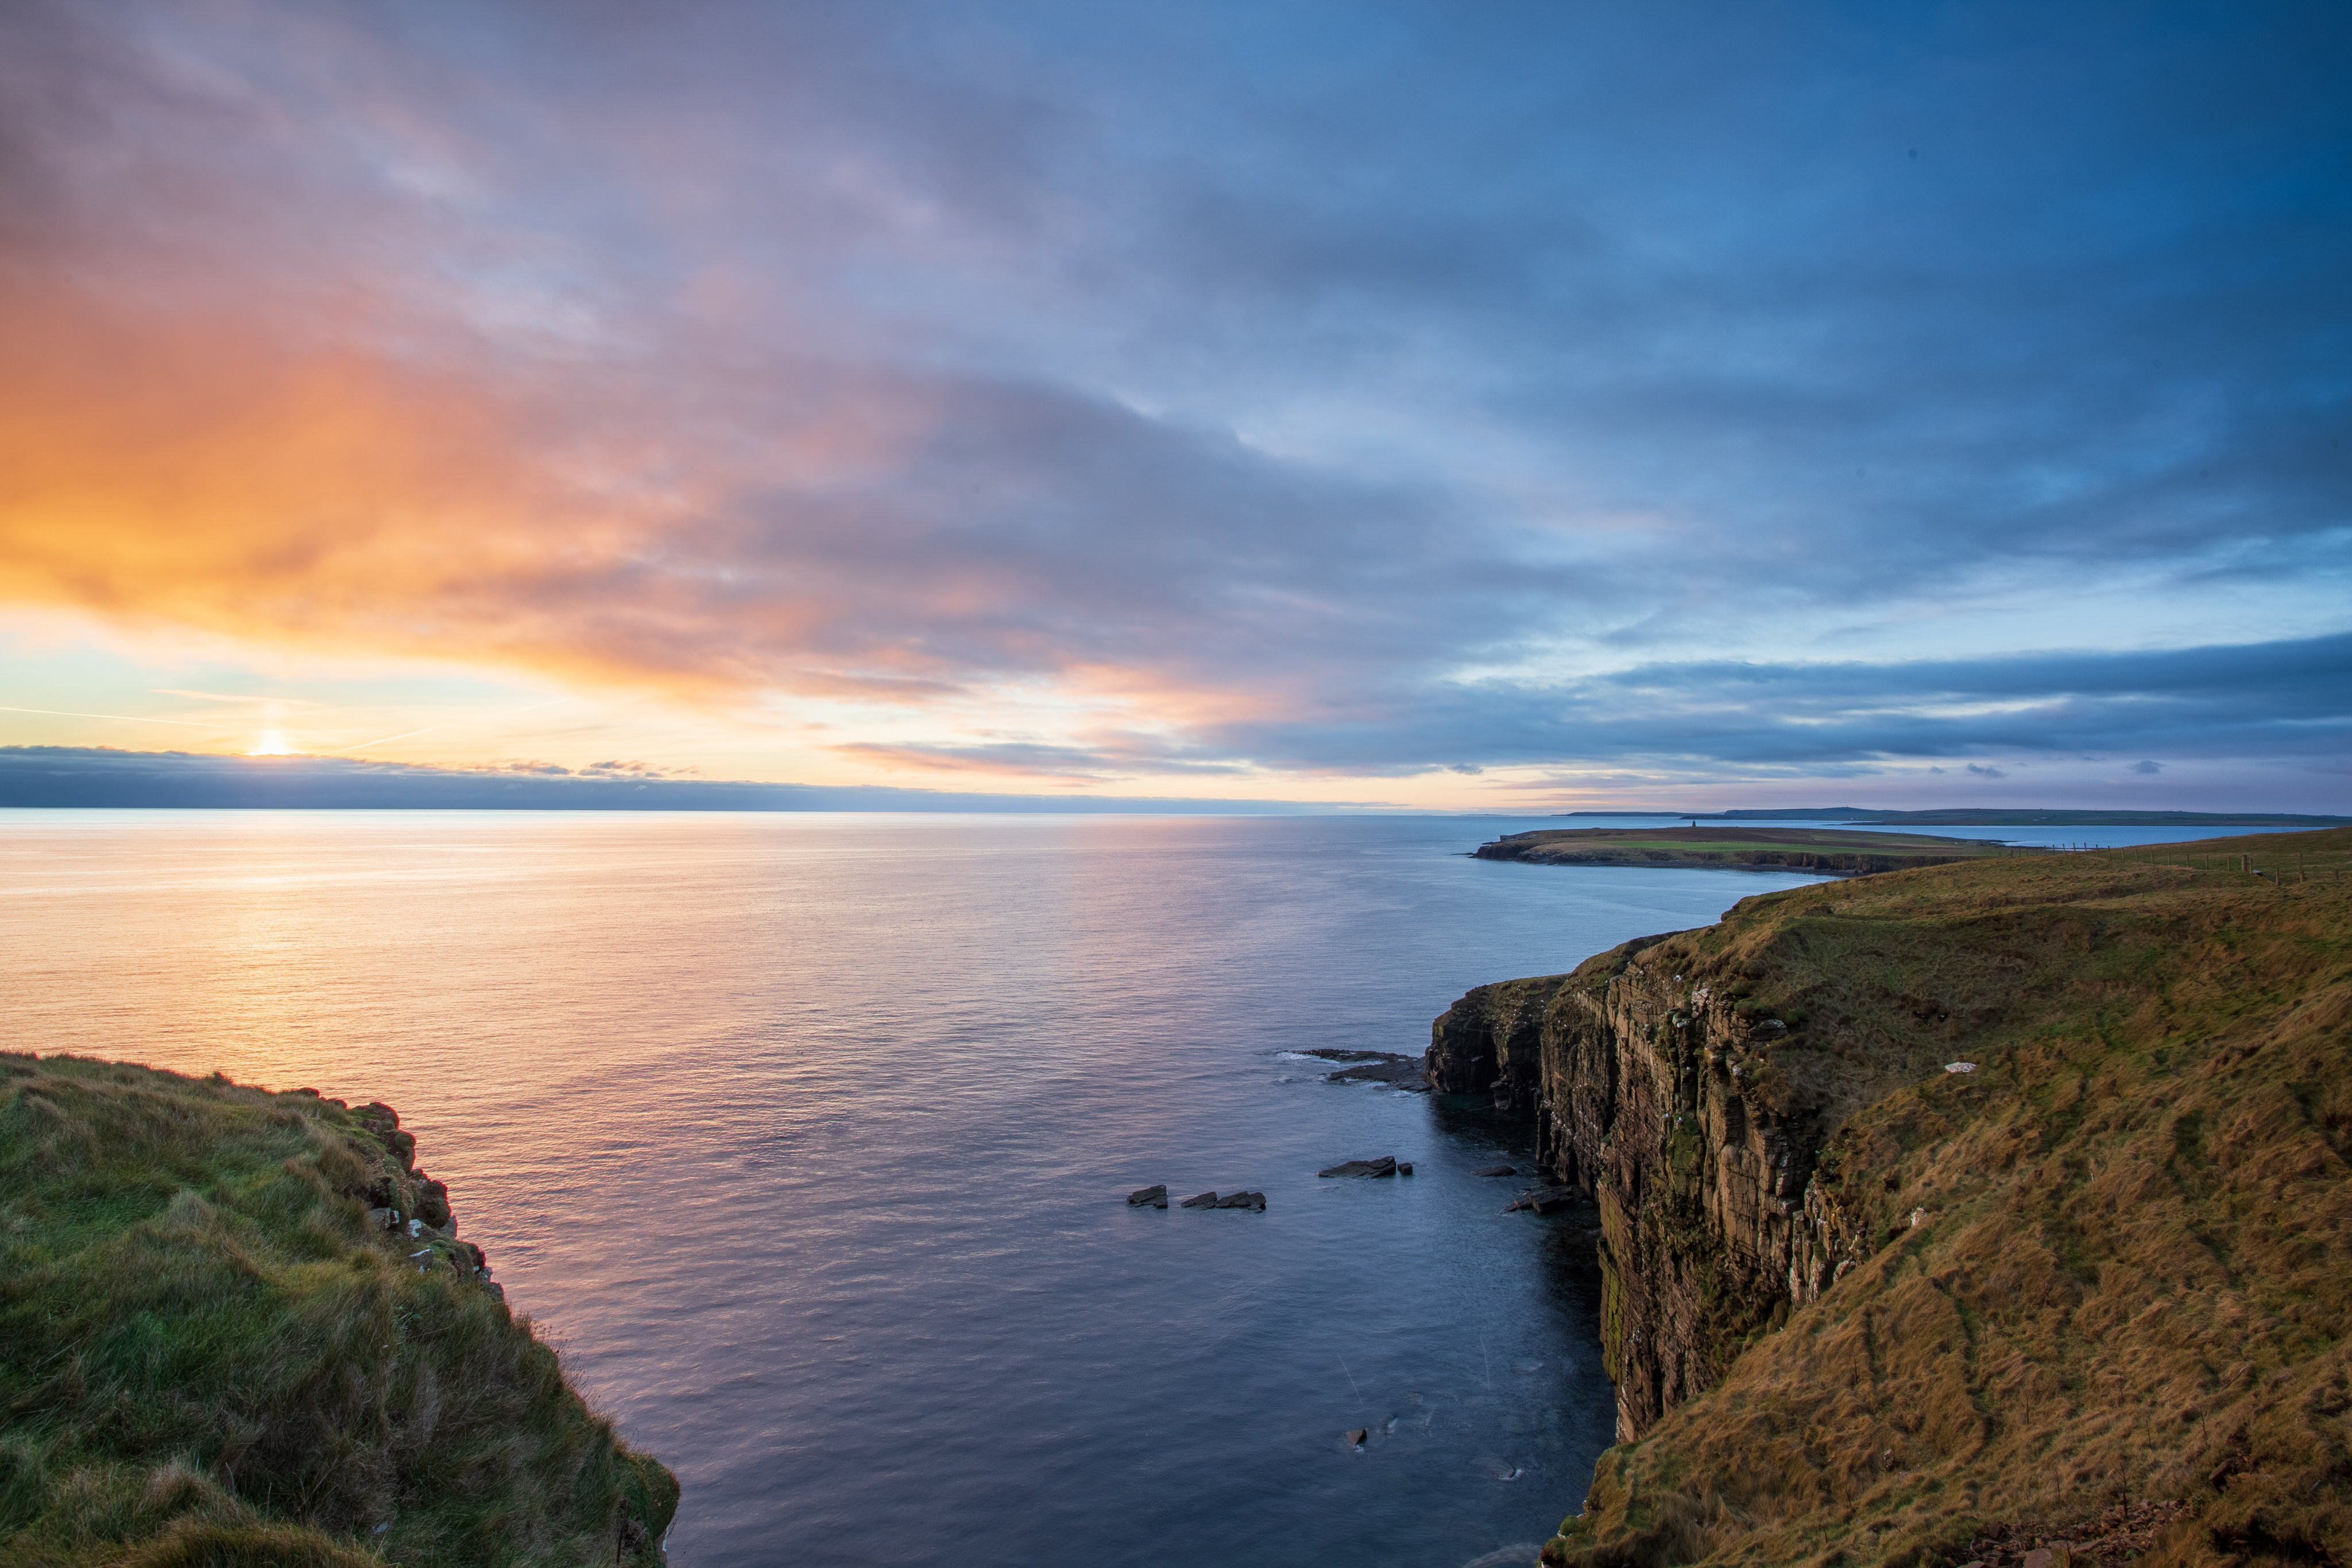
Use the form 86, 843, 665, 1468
0, 1053, 678, 1568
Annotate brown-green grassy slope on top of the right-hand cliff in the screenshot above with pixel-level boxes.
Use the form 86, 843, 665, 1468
1545, 830, 2352, 1568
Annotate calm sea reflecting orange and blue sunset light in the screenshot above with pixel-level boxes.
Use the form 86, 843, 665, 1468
0, 811, 2248, 1568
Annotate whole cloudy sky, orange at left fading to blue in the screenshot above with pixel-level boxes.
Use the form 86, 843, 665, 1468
0, 0, 2352, 811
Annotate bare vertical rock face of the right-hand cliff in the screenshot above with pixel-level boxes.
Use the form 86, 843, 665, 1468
1428, 936, 1854, 1441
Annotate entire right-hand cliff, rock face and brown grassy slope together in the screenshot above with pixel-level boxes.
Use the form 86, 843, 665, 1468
1428, 830, 2352, 1566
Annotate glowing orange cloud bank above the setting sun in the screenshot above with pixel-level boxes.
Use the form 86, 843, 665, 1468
0, 273, 974, 700
